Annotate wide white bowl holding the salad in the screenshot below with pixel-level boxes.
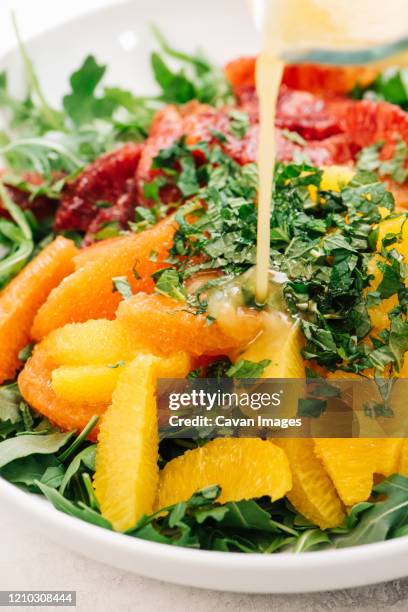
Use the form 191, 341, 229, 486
0, 0, 408, 593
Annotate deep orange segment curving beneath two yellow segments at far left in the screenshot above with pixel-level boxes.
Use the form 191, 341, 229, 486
18, 343, 107, 439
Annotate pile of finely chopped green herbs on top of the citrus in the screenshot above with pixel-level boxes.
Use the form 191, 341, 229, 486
149, 139, 408, 375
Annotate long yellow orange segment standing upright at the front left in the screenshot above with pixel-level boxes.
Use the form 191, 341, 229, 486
94, 355, 190, 531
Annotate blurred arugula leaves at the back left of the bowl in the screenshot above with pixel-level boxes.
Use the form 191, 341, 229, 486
0, 18, 233, 289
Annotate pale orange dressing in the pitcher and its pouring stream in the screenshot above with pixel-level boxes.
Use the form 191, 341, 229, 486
251, 0, 408, 304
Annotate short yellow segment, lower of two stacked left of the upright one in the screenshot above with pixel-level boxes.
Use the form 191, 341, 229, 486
51, 365, 123, 404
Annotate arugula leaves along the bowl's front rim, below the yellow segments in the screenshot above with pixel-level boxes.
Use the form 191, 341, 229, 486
0, 385, 408, 553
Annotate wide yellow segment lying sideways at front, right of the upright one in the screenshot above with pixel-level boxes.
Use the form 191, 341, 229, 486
156, 438, 292, 509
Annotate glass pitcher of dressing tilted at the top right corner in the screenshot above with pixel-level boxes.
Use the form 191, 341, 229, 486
248, 0, 408, 65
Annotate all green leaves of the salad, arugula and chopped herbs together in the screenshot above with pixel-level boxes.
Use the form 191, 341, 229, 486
0, 27, 408, 553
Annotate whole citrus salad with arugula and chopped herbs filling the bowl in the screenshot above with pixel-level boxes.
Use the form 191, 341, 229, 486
0, 32, 408, 553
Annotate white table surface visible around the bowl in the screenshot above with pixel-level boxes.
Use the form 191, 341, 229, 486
0, 0, 408, 612
